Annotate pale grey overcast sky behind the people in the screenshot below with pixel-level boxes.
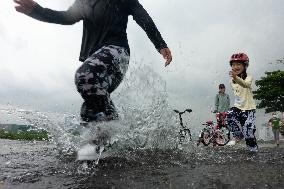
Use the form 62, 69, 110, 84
0, 0, 284, 123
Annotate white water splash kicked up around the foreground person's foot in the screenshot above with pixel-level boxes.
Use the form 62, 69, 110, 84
0, 64, 193, 164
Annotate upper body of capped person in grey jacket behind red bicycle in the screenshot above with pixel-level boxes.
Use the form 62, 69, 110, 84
214, 84, 230, 113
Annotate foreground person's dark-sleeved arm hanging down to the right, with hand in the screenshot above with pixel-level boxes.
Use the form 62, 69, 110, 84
128, 0, 172, 66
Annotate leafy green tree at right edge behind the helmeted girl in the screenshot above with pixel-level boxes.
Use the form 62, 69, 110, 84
253, 70, 284, 113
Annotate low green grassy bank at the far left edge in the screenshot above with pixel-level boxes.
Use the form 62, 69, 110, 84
0, 129, 48, 141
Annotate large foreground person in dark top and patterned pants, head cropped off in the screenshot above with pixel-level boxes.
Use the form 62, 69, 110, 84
14, 0, 172, 122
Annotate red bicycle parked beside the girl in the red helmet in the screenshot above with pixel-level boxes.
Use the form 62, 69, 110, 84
197, 112, 230, 146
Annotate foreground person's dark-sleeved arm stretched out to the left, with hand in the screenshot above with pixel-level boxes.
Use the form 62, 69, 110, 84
14, 0, 84, 25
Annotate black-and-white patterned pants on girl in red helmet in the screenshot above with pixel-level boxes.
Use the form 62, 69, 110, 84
227, 107, 257, 147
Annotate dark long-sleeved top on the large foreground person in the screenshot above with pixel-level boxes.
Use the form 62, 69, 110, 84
29, 0, 167, 61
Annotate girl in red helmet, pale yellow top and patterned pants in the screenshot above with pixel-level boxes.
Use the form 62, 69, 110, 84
227, 53, 258, 151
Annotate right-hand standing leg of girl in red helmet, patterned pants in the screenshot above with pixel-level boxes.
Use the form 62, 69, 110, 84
241, 110, 258, 149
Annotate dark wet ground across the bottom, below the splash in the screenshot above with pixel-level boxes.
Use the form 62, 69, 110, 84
0, 140, 284, 189
